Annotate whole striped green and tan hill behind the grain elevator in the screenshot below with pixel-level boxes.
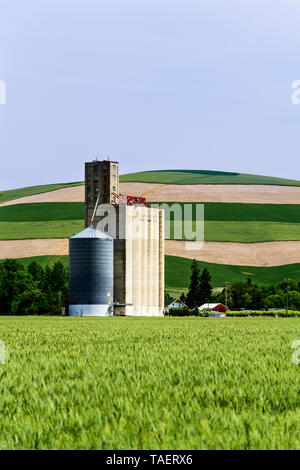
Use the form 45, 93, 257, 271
0, 170, 300, 288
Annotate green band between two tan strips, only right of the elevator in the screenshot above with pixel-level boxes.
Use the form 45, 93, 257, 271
155, 202, 300, 243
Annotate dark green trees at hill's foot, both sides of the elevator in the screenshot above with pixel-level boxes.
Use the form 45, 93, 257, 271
0, 259, 300, 315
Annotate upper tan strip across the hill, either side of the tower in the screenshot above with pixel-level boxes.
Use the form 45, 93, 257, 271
0, 183, 300, 206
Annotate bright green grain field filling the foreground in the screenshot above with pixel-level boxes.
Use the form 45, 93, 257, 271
0, 317, 300, 450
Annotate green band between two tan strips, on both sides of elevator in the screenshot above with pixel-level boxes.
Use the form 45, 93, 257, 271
0, 202, 300, 243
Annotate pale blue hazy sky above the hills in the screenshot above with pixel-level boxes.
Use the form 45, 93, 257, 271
0, 0, 300, 190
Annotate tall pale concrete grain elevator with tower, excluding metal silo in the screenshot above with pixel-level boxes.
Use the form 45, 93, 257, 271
85, 160, 165, 316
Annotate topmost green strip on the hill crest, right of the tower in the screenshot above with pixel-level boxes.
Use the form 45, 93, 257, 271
120, 170, 300, 186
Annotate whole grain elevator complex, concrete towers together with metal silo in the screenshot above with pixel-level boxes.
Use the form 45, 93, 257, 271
70, 160, 165, 316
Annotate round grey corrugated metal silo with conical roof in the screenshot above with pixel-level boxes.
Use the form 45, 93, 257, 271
69, 227, 114, 316
